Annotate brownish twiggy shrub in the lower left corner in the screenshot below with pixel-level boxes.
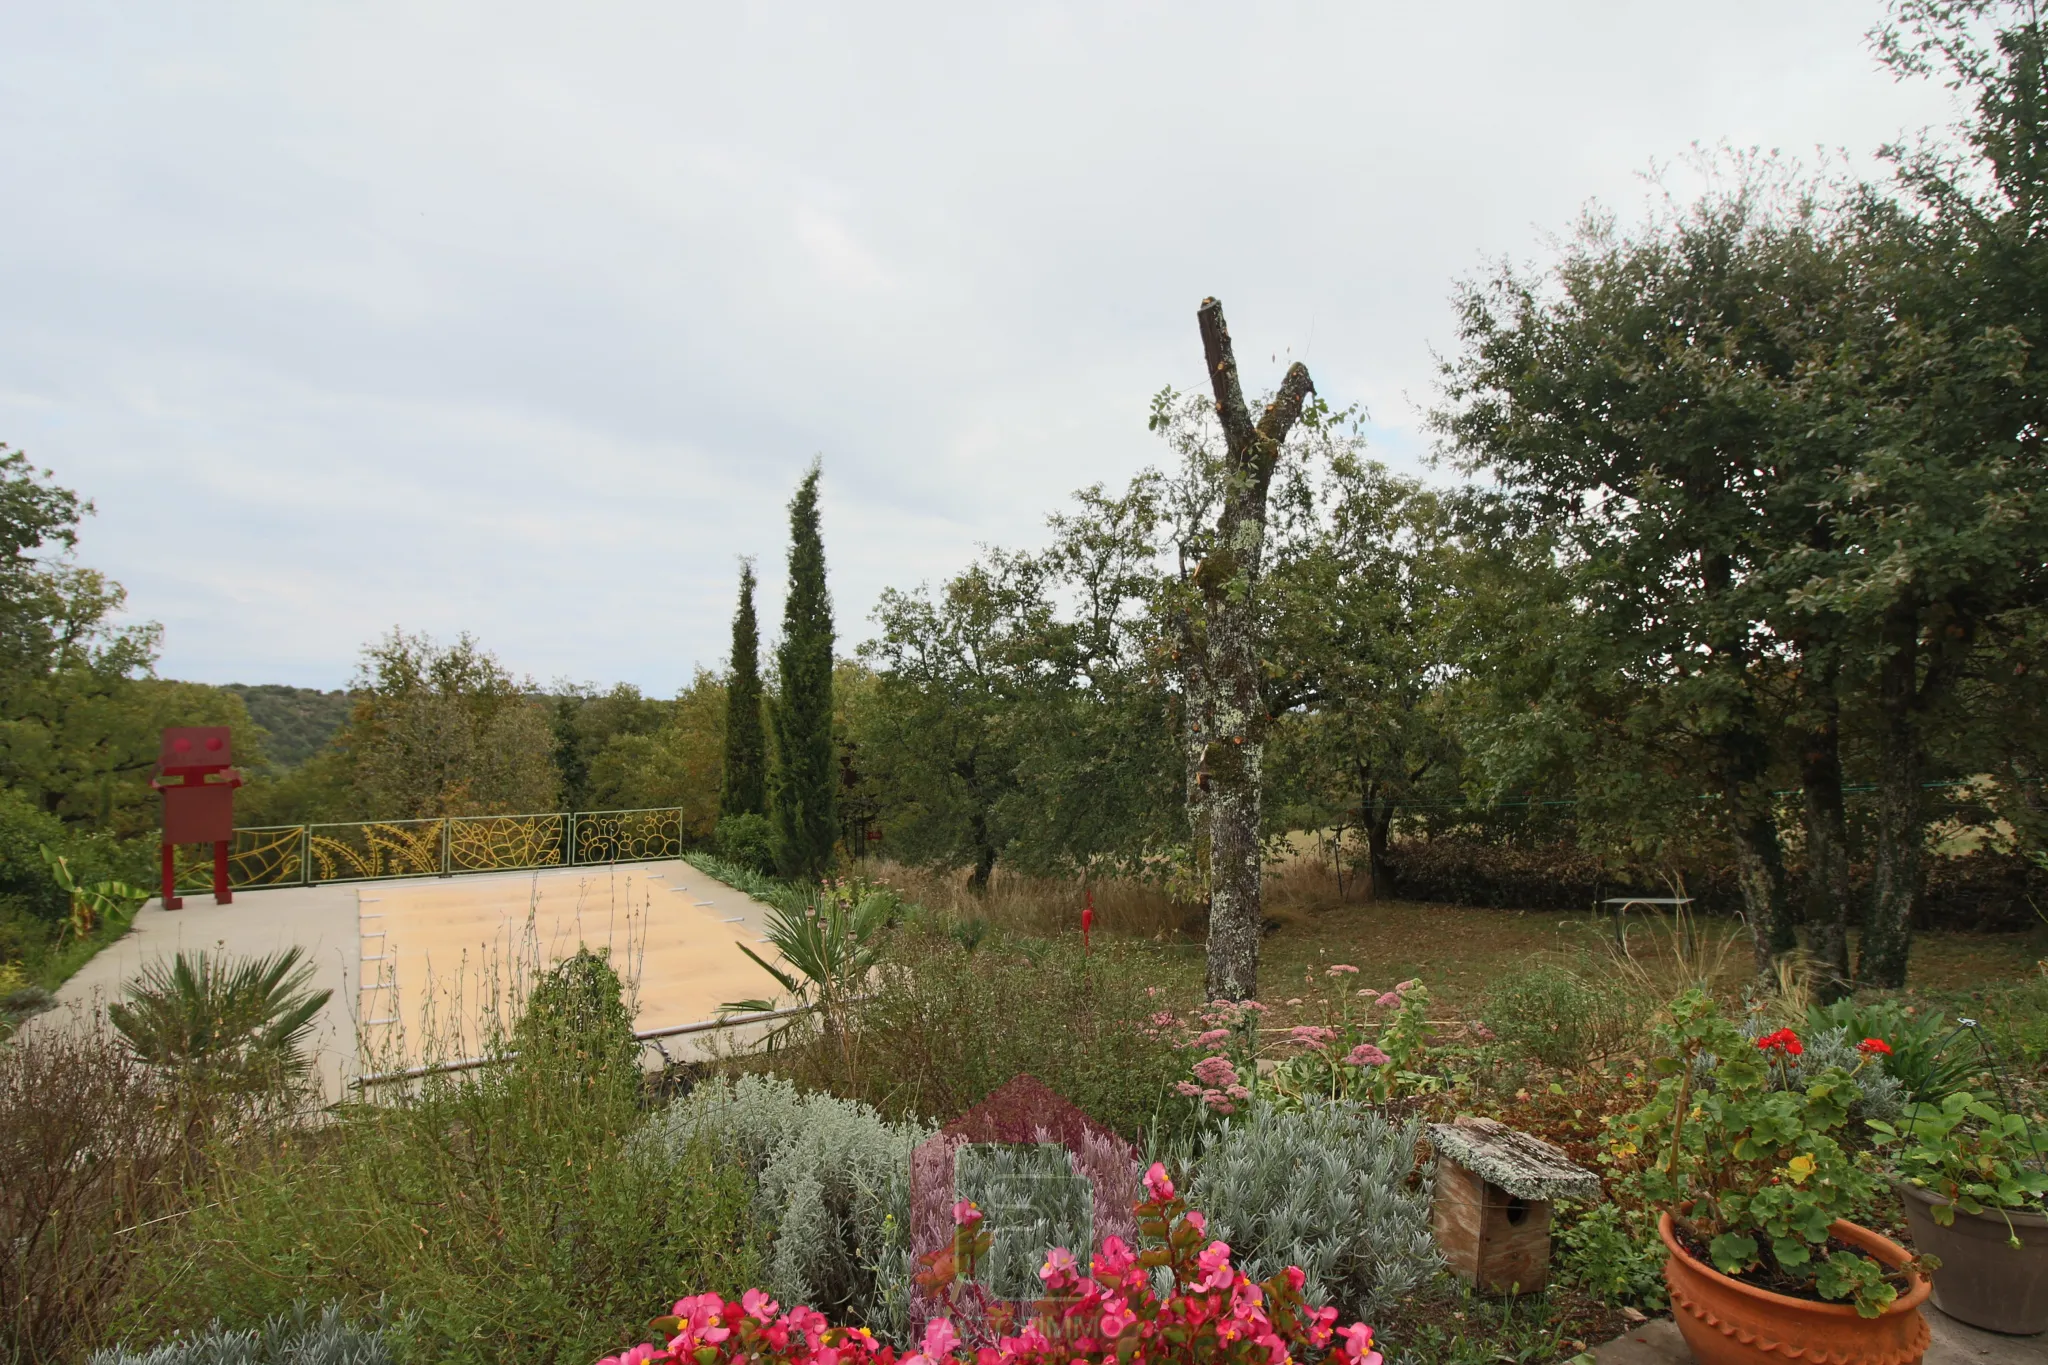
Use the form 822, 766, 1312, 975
0, 1023, 198, 1361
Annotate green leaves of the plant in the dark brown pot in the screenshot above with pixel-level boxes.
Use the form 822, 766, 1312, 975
1870, 1091, 2048, 1219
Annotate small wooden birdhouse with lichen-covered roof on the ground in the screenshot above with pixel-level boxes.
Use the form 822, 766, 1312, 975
1430, 1117, 1599, 1293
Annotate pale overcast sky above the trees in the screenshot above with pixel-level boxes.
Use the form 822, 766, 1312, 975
0, 0, 1954, 696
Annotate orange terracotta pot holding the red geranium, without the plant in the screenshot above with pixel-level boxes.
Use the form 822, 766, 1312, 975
1657, 1214, 1929, 1365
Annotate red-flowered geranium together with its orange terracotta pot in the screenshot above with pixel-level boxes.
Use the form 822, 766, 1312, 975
1622, 990, 1931, 1365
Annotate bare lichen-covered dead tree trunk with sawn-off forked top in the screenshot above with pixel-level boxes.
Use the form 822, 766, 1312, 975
1190, 299, 1315, 1001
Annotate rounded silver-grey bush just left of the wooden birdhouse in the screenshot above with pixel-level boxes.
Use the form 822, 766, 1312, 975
1188, 1101, 1444, 1318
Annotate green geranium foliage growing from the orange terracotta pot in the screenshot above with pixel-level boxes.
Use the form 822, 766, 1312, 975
1620, 990, 1898, 1318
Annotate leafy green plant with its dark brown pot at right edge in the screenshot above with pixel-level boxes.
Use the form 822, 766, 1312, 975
1870, 1091, 2048, 1336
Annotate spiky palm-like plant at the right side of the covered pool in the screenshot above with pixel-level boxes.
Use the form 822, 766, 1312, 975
723, 890, 897, 1081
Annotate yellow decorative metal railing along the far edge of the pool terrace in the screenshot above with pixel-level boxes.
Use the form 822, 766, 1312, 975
176, 806, 682, 892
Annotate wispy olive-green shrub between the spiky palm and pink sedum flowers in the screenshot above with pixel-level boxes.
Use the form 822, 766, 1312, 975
823, 917, 1184, 1140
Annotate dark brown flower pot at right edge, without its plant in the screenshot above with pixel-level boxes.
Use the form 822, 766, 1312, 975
1898, 1183, 2048, 1336
